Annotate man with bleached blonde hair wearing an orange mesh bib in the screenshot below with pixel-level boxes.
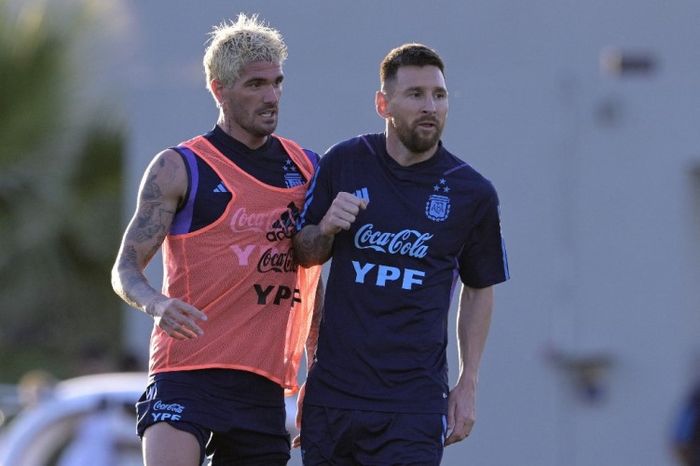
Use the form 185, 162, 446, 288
112, 14, 320, 466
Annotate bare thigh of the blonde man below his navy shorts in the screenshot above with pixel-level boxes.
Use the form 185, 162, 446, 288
142, 422, 203, 466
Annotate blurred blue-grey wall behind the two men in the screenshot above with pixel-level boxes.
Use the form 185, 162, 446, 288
3, 0, 700, 466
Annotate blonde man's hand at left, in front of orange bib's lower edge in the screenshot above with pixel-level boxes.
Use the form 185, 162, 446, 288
146, 296, 207, 340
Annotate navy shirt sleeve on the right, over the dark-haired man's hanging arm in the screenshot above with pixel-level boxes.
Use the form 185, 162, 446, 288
458, 186, 510, 288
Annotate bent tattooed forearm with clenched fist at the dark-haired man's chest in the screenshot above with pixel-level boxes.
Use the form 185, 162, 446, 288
294, 192, 367, 267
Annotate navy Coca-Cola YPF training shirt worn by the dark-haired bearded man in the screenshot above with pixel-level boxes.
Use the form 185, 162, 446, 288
299, 134, 509, 413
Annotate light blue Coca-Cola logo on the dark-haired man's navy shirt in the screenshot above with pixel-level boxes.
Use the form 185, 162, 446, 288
355, 223, 433, 258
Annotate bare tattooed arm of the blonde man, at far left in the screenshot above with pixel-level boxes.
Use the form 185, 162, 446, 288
112, 149, 206, 339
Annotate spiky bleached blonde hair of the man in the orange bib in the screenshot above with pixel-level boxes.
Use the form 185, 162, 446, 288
203, 13, 287, 95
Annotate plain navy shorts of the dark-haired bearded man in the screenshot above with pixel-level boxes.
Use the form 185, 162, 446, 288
301, 404, 447, 466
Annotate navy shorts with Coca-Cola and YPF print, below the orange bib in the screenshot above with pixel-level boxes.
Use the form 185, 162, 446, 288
136, 369, 290, 466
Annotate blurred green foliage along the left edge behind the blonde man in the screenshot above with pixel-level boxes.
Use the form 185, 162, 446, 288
0, 1, 124, 382
